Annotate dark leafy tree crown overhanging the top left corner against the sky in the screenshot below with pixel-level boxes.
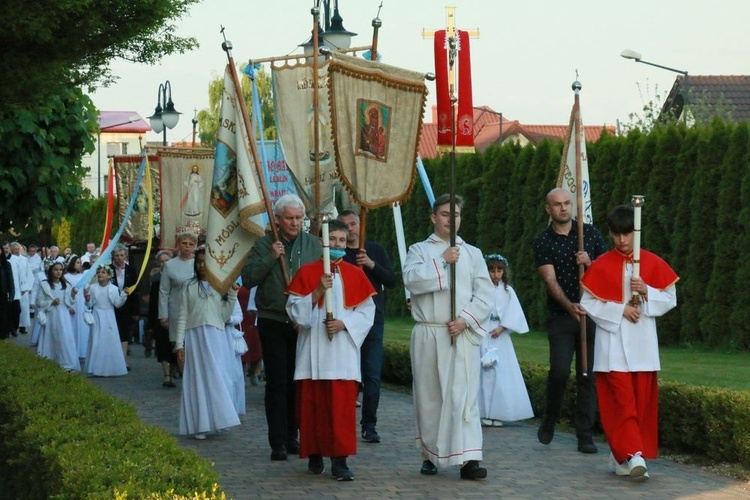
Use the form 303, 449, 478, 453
0, 0, 198, 109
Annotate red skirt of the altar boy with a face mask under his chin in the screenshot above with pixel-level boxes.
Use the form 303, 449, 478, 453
297, 380, 359, 458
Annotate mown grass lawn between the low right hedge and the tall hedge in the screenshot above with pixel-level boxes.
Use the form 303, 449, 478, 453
385, 318, 750, 391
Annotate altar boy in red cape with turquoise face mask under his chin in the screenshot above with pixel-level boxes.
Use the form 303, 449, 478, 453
286, 220, 375, 481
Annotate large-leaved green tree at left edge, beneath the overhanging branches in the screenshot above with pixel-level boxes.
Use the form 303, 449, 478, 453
0, 89, 98, 233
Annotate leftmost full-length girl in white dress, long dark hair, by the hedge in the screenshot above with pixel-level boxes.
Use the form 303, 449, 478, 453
36, 262, 81, 371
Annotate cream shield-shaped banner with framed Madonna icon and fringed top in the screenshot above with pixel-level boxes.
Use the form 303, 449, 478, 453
328, 50, 427, 209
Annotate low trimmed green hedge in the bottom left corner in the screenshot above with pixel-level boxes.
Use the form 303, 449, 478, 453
0, 342, 224, 499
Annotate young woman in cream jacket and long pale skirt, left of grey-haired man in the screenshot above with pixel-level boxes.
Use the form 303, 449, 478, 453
175, 249, 240, 439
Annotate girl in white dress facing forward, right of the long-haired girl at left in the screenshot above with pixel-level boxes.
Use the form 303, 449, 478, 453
84, 265, 128, 377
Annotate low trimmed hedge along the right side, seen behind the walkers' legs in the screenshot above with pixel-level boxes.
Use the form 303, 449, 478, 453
382, 340, 750, 467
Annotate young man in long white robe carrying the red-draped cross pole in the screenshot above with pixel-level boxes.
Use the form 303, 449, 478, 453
403, 195, 494, 479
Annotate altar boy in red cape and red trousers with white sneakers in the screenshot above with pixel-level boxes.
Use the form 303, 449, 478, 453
581, 205, 679, 481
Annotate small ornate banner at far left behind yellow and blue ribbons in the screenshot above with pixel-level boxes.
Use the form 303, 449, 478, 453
112, 155, 161, 241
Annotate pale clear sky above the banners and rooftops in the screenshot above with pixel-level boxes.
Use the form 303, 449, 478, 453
92, 0, 750, 142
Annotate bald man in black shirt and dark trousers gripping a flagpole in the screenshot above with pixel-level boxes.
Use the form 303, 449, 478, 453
534, 188, 608, 453
